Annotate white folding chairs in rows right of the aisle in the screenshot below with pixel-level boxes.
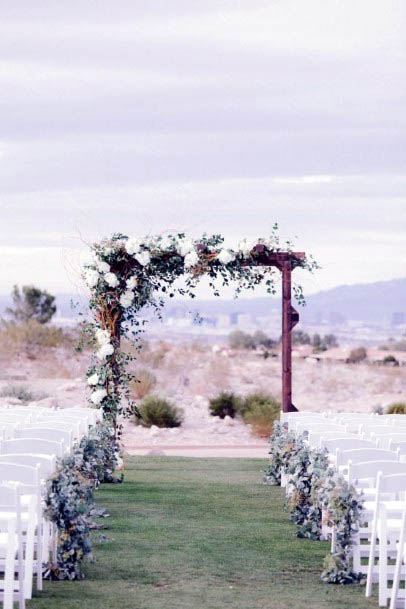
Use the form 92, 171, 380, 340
284, 412, 406, 609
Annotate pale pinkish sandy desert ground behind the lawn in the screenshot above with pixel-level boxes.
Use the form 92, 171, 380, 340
0, 332, 406, 456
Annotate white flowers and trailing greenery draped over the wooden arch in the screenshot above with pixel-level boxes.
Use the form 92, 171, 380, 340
83, 230, 317, 425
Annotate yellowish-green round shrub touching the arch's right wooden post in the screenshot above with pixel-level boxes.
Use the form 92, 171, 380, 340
241, 393, 281, 438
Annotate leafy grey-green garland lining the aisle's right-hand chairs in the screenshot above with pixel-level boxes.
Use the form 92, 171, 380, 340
264, 423, 363, 584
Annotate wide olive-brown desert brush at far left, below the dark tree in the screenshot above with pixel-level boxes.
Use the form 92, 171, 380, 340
0, 320, 73, 356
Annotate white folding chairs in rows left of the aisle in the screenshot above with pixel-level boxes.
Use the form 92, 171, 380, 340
0, 407, 100, 609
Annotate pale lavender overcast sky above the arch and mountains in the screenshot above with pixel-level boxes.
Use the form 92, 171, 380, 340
0, 0, 406, 292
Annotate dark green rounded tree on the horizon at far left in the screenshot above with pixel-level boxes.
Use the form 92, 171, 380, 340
6, 285, 56, 324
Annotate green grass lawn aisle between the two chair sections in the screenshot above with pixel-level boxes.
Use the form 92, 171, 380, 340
28, 457, 377, 609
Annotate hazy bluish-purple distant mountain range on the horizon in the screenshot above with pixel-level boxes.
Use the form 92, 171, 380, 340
0, 278, 406, 324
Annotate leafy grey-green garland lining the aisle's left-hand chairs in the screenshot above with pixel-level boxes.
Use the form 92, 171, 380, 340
45, 423, 119, 580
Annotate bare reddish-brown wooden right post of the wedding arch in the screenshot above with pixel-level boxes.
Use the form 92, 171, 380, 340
281, 260, 299, 412
